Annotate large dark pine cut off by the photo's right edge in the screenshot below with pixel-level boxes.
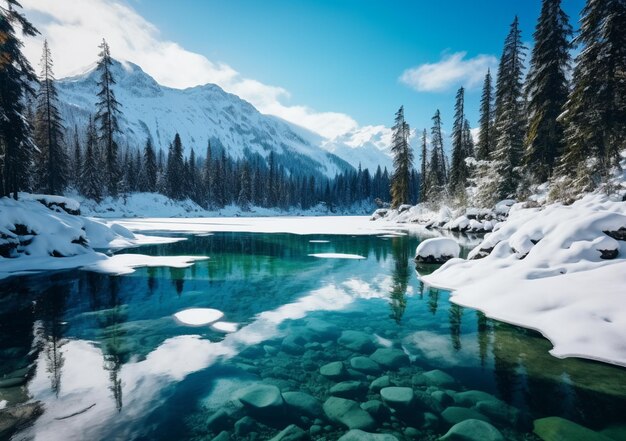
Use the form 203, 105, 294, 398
558, 0, 626, 193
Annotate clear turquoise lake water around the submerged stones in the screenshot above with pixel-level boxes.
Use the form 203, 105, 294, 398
0, 233, 626, 440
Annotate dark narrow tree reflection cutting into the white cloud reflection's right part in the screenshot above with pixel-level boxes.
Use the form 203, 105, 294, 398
98, 276, 128, 412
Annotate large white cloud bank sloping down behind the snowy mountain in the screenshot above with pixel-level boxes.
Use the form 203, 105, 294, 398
21, 0, 358, 138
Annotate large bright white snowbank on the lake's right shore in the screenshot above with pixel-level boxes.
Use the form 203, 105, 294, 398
423, 194, 626, 366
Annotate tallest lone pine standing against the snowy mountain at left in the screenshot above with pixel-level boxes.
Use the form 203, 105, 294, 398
95, 39, 121, 196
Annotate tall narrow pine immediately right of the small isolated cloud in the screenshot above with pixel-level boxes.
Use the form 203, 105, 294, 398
493, 16, 526, 198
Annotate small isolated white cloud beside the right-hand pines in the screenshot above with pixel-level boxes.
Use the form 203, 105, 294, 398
400, 52, 498, 92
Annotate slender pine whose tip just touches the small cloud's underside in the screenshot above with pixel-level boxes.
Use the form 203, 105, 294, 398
448, 87, 469, 195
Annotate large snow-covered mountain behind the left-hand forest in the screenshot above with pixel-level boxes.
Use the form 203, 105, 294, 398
58, 61, 390, 177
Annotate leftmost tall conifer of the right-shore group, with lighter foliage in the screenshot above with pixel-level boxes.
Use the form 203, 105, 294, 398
391, 106, 413, 208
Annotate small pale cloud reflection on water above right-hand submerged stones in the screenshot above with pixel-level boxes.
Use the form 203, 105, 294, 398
402, 331, 480, 368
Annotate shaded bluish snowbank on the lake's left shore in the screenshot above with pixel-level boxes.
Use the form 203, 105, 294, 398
0, 194, 192, 279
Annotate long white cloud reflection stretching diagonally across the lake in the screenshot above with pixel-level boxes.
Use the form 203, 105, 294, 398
24, 278, 388, 441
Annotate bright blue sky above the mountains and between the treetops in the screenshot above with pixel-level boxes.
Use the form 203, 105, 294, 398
131, 0, 584, 133
